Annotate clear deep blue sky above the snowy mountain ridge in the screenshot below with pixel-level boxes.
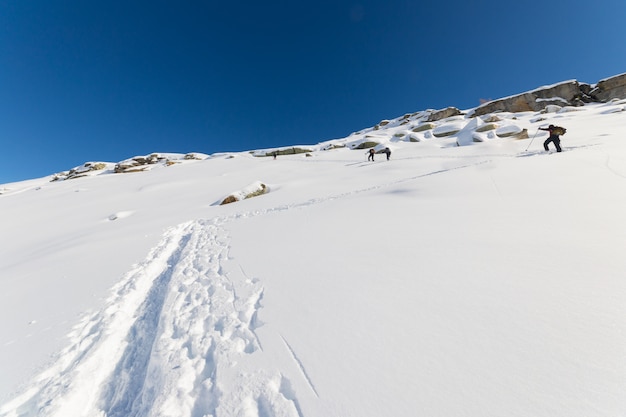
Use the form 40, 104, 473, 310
0, 0, 626, 183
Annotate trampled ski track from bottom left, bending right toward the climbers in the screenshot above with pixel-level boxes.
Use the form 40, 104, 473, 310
0, 159, 490, 417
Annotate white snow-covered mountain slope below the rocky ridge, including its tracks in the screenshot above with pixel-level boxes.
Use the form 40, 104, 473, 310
0, 100, 626, 417
